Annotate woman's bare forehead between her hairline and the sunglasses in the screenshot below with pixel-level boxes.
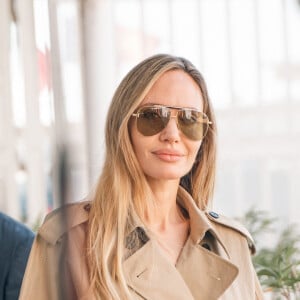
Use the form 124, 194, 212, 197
141, 70, 203, 110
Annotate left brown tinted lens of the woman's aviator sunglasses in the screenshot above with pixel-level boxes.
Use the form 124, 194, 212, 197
137, 107, 170, 136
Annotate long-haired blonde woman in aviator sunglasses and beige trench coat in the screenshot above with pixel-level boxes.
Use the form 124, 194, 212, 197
21, 54, 262, 300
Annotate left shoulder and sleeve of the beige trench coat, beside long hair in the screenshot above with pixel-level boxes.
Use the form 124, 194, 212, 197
19, 202, 89, 300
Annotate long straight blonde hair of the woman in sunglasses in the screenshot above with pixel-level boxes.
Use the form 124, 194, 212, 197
87, 54, 216, 300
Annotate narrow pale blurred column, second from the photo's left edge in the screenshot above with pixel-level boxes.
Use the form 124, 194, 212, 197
17, 0, 46, 222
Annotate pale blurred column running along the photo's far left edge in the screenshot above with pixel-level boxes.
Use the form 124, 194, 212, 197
0, 0, 19, 218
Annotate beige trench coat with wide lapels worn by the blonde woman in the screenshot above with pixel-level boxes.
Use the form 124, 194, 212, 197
20, 188, 263, 300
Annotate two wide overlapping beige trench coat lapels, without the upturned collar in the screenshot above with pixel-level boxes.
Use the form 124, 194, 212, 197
123, 239, 238, 300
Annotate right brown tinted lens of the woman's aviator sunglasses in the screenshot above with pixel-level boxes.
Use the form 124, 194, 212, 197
178, 109, 209, 141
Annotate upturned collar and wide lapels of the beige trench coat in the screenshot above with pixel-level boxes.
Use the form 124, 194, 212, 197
123, 188, 238, 300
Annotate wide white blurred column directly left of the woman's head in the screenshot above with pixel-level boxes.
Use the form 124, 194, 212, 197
82, 0, 116, 184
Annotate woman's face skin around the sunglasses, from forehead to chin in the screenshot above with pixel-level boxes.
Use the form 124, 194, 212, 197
130, 70, 203, 180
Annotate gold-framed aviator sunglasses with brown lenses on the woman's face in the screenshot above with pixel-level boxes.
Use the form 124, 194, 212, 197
132, 105, 212, 141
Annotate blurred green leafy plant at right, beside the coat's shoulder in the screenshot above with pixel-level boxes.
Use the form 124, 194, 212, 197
240, 208, 300, 299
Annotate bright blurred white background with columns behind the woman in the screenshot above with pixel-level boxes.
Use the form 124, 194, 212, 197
0, 0, 300, 230
